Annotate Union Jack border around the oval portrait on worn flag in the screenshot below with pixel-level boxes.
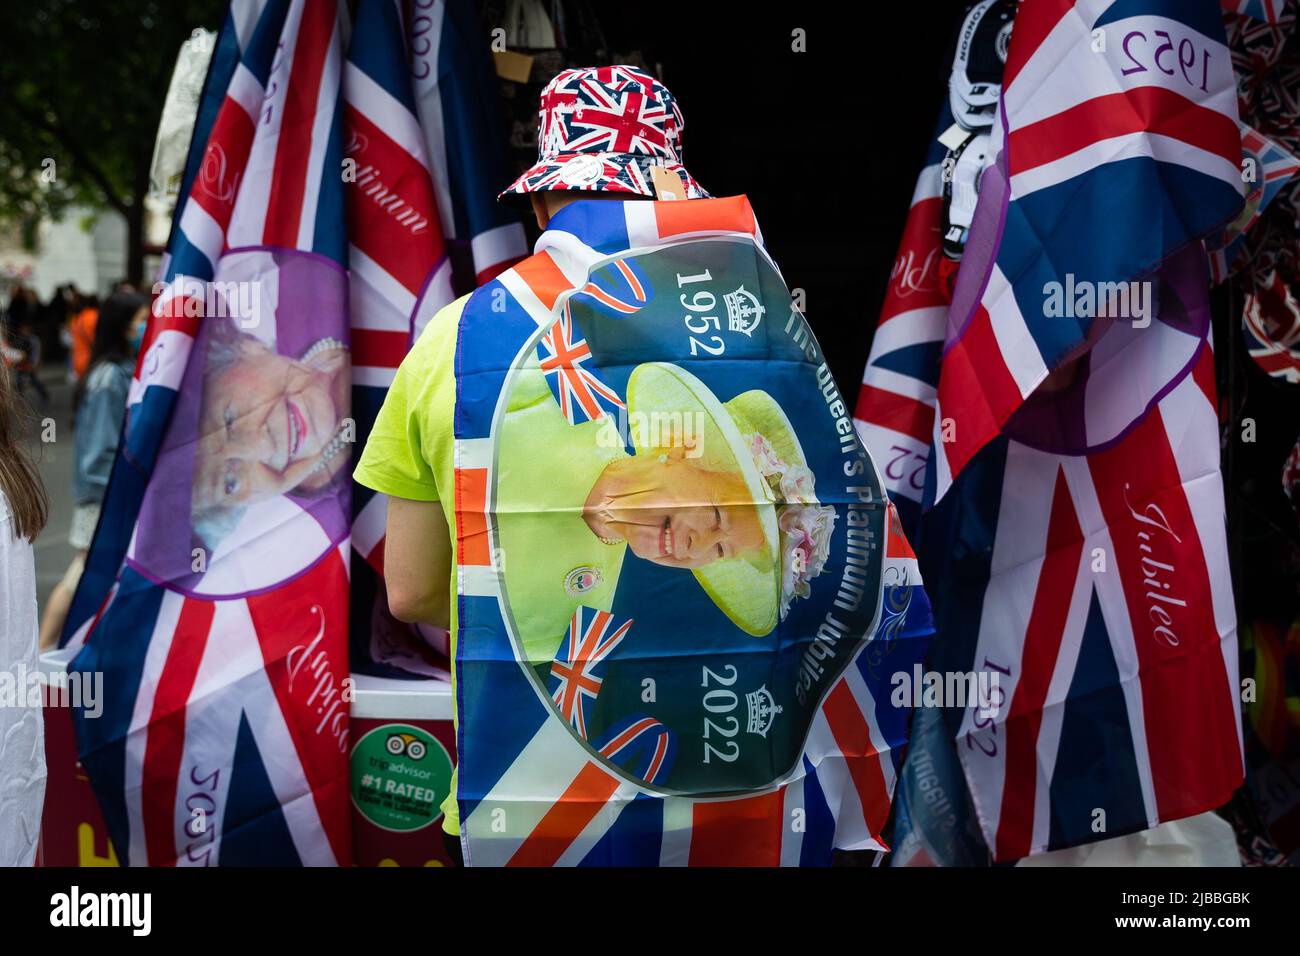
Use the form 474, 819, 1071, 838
455, 196, 930, 866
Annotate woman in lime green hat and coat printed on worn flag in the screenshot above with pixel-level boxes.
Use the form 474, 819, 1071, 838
494, 360, 835, 663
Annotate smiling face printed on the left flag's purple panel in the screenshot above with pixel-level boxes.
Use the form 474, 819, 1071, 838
192, 336, 347, 512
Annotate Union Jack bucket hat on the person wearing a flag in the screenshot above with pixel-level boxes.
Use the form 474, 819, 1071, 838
498, 66, 710, 199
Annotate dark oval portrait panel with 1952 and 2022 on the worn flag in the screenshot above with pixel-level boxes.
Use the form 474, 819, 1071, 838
458, 218, 909, 795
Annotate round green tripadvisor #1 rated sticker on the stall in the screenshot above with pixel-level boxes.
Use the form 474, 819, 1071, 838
352, 723, 451, 832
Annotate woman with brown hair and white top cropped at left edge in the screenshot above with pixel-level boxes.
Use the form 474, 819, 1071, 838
0, 353, 48, 866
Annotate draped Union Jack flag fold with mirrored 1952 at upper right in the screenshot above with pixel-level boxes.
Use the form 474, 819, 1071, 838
931, 0, 1243, 499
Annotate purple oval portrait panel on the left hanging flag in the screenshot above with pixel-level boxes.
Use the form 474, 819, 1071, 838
129, 250, 355, 597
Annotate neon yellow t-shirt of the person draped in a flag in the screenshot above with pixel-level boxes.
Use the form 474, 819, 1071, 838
352, 295, 469, 836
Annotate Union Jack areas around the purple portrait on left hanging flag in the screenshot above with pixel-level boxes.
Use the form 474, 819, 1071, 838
65, 0, 351, 865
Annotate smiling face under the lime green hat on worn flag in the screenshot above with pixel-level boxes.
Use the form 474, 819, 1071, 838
582, 447, 764, 568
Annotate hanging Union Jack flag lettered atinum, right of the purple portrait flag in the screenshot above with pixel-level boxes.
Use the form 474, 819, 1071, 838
343, 0, 452, 675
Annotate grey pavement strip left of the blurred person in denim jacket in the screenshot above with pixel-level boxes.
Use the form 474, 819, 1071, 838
25, 368, 73, 621
